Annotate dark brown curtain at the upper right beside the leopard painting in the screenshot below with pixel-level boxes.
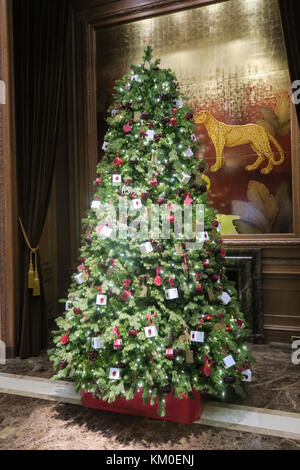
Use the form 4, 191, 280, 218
279, 0, 300, 124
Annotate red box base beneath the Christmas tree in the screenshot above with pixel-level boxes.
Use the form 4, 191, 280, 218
81, 390, 204, 423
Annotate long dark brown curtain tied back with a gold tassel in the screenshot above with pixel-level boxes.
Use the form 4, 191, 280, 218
13, 0, 69, 359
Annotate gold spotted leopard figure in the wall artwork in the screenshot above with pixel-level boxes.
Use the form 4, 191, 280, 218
194, 111, 285, 175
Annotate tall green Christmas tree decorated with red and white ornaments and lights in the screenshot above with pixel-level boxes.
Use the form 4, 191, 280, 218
49, 46, 251, 416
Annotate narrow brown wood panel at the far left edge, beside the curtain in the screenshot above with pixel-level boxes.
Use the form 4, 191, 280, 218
0, 0, 19, 357
